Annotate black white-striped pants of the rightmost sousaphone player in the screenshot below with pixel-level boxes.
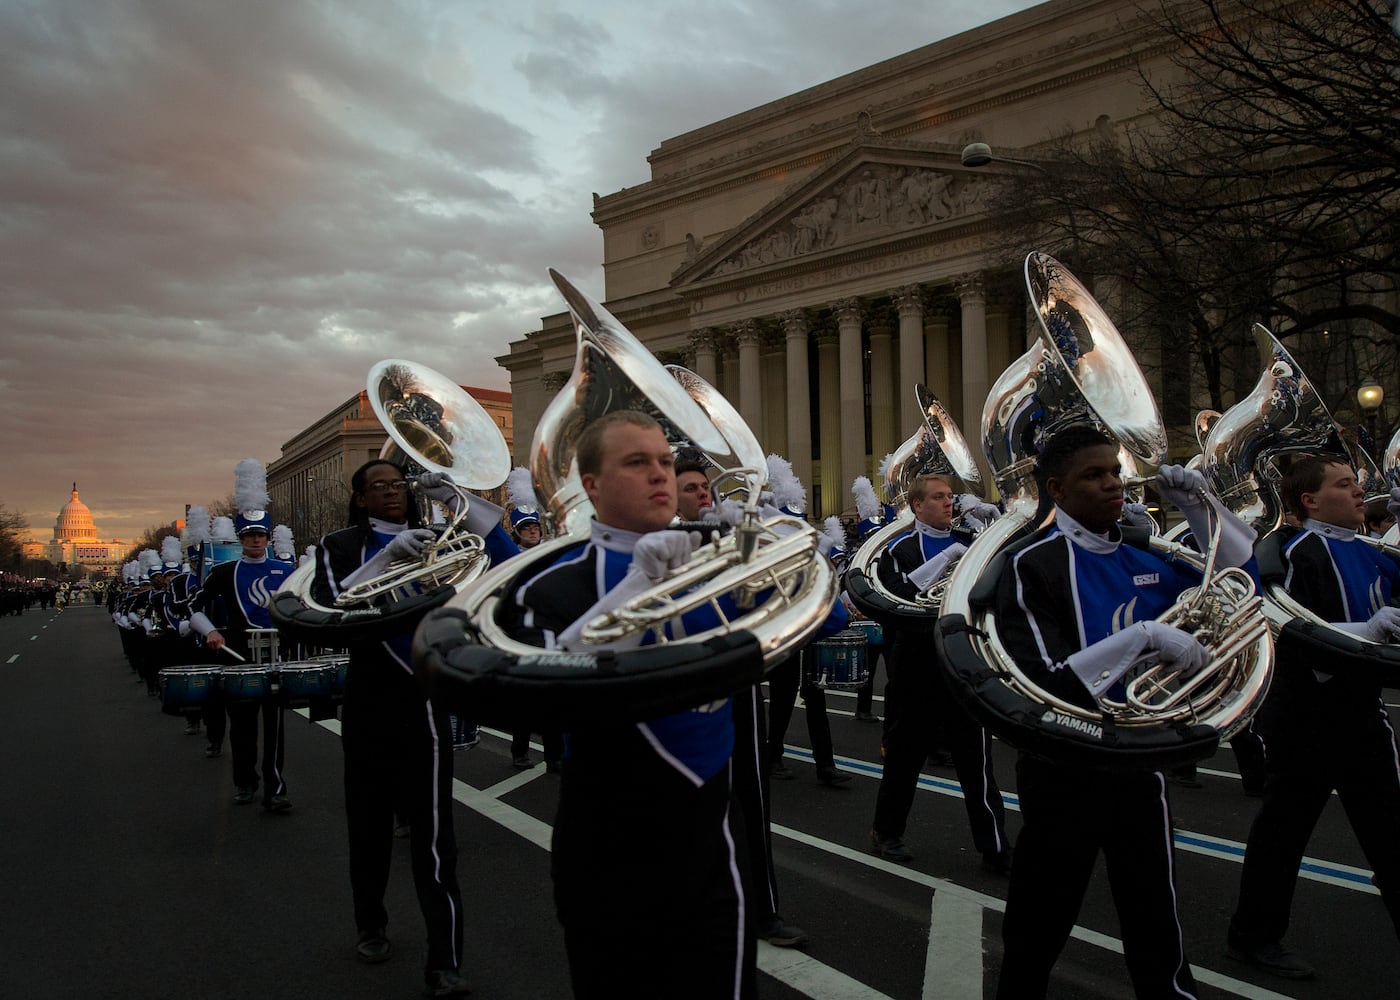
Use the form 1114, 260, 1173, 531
1229, 654, 1400, 948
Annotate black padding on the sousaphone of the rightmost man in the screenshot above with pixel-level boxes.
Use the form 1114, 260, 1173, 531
1254, 525, 1400, 688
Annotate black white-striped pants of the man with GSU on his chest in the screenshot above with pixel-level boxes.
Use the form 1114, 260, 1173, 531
997, 755, 1196, 1000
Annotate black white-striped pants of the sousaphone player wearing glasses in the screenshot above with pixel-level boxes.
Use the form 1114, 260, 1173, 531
340, 658, 462, 972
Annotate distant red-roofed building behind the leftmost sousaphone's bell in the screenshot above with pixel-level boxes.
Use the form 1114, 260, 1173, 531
267, 385, 515, 552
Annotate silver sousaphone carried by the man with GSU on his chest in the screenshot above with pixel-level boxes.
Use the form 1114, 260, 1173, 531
937, 254, 1273, 769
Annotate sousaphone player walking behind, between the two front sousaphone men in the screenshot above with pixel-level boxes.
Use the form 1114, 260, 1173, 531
871, 475, 1011, 874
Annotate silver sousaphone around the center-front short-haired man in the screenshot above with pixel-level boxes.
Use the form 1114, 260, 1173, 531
413, 270, 836, 728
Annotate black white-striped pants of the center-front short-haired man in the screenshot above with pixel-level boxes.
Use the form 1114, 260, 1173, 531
552, 727, 757, 1000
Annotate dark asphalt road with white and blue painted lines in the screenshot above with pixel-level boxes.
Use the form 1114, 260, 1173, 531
0, 606, 1400, 1000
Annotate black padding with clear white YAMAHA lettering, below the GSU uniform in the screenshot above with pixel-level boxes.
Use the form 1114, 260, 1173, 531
935, 615, 1219, 772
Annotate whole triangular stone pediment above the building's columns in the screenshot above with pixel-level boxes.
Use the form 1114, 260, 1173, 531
671, 143, 997, 284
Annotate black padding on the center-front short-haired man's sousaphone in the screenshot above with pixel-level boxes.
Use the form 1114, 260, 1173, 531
413, 608, 764, 731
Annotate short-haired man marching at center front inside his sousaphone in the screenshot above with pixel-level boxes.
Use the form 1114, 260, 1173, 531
517, 410, 844, 1000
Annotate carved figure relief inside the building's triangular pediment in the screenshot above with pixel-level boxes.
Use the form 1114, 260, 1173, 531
713, 164, 995, 275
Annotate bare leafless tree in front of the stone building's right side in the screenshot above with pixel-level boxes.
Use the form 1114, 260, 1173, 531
980, 0, 1400, 439
